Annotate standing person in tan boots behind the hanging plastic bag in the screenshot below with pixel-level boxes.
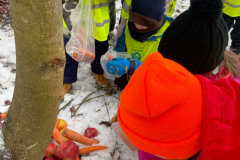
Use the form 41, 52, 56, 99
62, 0, 110, 99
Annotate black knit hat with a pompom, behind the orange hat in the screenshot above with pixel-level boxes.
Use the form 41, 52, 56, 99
158, 0, 228, 74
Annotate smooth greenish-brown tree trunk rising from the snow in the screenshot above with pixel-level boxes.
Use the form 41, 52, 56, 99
2, 0, 65, 160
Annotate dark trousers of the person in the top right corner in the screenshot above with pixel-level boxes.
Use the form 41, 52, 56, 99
222, 13, 240, 49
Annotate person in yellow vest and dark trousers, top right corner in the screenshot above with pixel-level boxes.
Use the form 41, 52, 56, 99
223, 0, 240, 55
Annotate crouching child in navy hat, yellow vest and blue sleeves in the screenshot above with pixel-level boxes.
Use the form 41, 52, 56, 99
114, 0, 173, 89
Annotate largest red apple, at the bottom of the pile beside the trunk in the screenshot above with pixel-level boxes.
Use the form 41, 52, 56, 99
54, 140, 79, 160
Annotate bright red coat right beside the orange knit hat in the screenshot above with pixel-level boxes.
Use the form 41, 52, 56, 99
197, 76, 240, 160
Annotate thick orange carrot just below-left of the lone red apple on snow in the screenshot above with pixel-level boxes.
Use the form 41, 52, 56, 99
61, 128, 98, 145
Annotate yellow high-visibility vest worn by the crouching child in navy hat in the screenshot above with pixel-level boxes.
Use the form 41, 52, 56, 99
125, 16, 173, 62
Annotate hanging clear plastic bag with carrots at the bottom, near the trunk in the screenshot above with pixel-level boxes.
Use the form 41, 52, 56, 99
66, 0, 95, 63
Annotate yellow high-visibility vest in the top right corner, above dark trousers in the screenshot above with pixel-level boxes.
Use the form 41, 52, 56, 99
223, 0, 240, 17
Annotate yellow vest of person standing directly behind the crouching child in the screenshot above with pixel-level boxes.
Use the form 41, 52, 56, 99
121, 0, 177, 20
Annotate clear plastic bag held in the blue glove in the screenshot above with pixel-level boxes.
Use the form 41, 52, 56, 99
100, 49, 131, 81
